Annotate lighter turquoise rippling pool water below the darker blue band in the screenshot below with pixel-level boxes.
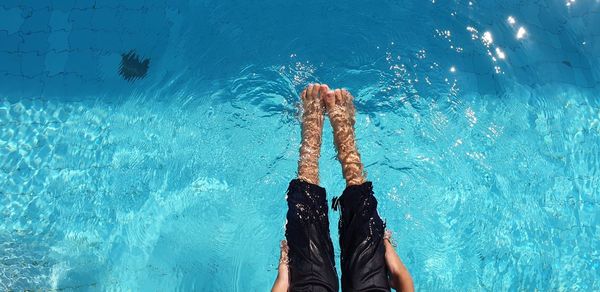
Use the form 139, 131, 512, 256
0, 66, 600, 290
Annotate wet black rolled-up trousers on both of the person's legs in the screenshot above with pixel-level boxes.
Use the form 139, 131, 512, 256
286, 179, 390, 292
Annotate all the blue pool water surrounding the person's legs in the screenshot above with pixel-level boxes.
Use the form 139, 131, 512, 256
0, 0, 600, 291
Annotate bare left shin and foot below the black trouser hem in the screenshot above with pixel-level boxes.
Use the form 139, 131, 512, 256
298, 83, 329, 184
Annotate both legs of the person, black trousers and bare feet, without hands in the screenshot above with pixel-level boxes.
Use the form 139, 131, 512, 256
278, 84, 390, 291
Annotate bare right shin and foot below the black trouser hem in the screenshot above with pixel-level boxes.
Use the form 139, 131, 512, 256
325, 89, 365, 185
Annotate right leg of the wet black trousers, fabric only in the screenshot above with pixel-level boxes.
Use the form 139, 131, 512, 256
334, 182, 390, 292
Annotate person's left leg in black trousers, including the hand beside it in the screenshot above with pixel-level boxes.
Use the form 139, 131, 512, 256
272, 84, 339, 292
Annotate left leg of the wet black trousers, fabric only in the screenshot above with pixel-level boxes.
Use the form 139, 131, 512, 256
285, 179, 339, 292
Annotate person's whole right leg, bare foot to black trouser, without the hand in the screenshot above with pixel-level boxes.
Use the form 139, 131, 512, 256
325, 89, 390, 292
